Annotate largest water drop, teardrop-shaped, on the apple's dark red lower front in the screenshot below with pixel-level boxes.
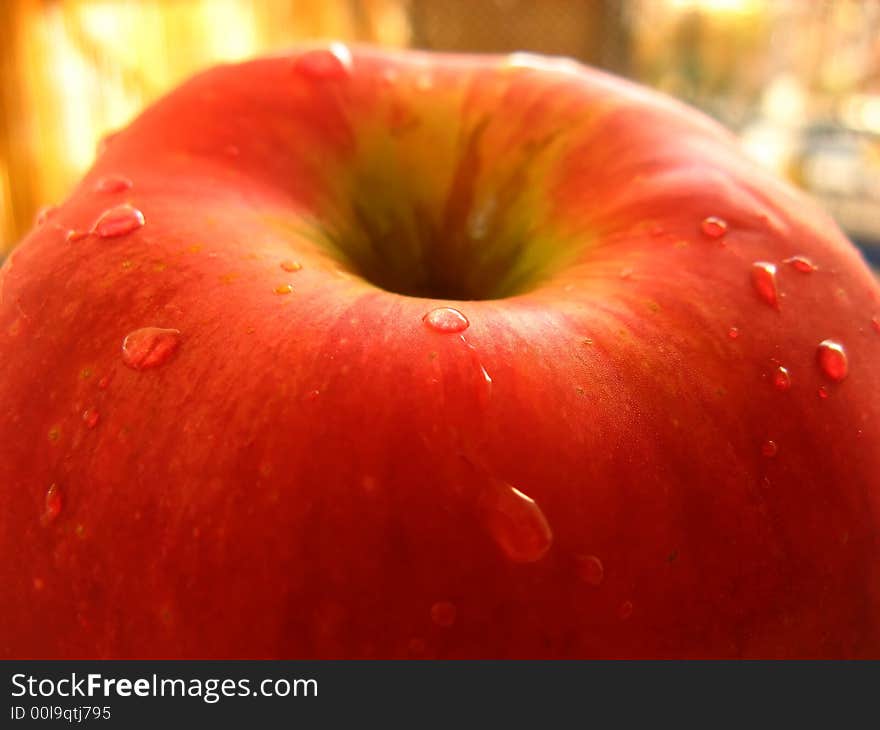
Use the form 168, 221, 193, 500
483, 480, 553, 563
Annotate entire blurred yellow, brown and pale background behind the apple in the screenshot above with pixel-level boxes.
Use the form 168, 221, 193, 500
0, 0, 880, 266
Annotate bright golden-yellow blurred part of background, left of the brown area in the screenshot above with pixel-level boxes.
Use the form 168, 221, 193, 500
0, 0, 410, 254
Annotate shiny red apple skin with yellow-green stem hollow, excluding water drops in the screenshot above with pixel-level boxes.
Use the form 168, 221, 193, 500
0, 46, 880, 658
